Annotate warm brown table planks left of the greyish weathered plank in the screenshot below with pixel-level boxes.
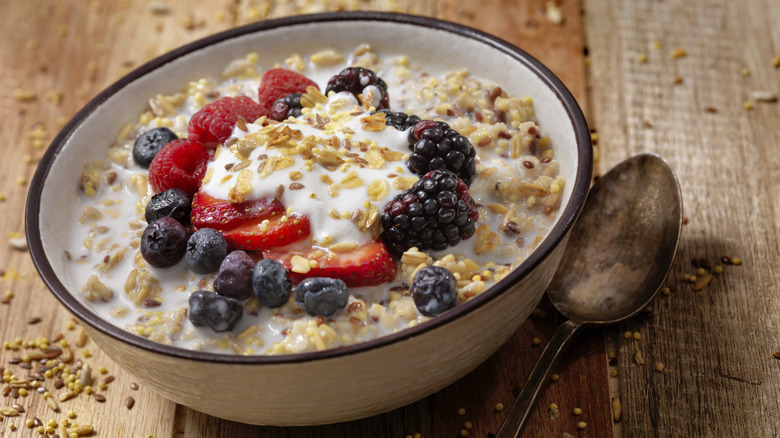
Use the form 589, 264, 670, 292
0, 0, 612, 437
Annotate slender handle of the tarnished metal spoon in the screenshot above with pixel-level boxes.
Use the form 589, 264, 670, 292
496, 320, 582, 438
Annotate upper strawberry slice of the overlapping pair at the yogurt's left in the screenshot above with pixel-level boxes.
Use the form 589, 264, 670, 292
192, 192, 284, 231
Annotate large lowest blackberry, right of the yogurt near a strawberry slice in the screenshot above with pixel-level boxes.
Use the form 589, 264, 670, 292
381, 170, 479, 256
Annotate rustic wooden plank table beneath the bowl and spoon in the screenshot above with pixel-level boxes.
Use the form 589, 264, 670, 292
0, 0, 780, 438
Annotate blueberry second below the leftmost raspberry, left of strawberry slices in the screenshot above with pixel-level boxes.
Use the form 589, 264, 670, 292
141, 216, 187, 268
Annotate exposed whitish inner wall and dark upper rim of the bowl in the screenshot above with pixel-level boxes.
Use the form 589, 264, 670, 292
28, 14, 590, 362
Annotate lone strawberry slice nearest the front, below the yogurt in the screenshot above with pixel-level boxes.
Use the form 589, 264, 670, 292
263, 240, 396, 287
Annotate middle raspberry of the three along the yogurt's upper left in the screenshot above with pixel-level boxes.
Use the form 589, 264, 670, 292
187, 96, 266, 144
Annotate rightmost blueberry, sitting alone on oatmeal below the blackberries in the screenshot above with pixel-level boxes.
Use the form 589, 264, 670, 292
410, 266, 458, 316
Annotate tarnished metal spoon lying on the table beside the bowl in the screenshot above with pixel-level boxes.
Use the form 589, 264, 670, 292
496, 154, 682, 438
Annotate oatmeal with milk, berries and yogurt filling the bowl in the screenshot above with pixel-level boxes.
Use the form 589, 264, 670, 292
68, 45, 564, 355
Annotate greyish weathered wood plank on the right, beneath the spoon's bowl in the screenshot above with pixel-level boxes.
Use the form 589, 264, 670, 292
584, 1, 780, 437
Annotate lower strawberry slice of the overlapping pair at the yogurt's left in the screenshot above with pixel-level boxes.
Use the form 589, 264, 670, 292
222, 213, 310, 251
